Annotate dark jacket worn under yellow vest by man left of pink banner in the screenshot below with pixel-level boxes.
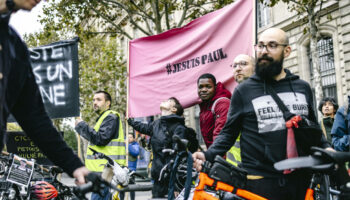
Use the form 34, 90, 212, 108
75, 111, 119, 146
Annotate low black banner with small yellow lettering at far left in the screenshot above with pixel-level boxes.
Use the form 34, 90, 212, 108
6, 132, 63, 165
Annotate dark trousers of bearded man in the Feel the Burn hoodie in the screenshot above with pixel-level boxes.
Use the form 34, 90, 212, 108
246, 172, 311, 200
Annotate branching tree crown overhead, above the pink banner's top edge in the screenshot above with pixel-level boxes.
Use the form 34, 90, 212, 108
41, 0, 233, 39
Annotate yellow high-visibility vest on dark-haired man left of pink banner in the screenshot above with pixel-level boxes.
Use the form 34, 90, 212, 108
85, 110, 126, 172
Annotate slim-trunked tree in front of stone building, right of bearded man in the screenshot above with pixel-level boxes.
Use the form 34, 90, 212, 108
266, 0, 331, 111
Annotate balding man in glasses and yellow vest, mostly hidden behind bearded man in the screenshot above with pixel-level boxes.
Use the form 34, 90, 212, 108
226, 54, 254, 166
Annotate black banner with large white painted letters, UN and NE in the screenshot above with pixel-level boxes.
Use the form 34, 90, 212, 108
29, 38, 79, 118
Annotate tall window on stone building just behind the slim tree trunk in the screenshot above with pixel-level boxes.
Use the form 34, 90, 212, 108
308, 37, 337, 99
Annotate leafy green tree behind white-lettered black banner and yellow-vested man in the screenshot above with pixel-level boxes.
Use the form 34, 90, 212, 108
24, 20, 126, 156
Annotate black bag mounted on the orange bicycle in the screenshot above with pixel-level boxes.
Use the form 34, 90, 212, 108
208, 156, 248, 188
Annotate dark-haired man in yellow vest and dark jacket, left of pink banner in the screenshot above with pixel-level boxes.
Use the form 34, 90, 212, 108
75, 91, 126, 200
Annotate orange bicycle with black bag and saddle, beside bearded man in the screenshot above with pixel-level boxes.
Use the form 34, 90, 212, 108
193, 147, 350, 200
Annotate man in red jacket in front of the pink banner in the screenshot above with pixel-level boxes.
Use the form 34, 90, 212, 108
197, 74, 231, 148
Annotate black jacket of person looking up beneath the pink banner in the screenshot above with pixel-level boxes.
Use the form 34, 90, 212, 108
128, 114, 186, 180
